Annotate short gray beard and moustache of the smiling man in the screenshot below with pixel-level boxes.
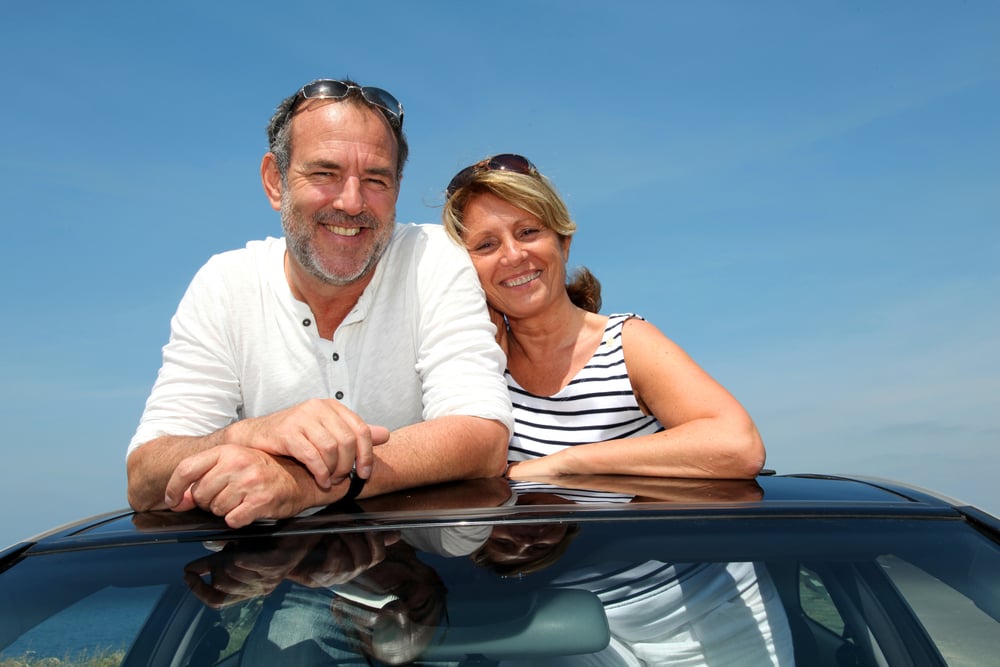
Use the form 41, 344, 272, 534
281, 189, 394, 287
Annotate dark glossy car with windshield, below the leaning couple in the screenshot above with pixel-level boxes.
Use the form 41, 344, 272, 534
0, 475, 1000, 667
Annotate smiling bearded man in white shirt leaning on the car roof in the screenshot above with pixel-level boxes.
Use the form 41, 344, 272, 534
127, 79, 512, 527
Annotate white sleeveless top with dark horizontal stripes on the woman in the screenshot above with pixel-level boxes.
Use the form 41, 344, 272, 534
504, 313, 663, 461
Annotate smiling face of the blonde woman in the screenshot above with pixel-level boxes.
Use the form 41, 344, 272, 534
462, 193, 570, 319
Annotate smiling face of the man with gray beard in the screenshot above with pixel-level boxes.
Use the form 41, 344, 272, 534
271, 100, 399, 285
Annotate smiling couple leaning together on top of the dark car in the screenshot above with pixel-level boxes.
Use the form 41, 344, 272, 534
127, 79, 764, 527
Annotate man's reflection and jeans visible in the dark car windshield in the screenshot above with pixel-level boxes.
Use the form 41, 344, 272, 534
184, 531, 446, 665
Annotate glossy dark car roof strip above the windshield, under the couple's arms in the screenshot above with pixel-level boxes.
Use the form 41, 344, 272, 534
0, 474, 1000, 570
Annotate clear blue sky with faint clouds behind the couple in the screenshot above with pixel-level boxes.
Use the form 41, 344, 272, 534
0, 0, 1000, 546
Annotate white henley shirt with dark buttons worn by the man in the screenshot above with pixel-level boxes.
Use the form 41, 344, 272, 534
128, 224, 513, 453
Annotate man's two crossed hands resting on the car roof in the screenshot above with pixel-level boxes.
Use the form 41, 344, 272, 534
164, 399, 389, 528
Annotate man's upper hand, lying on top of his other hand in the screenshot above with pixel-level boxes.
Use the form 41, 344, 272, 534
224, 399, 389, 489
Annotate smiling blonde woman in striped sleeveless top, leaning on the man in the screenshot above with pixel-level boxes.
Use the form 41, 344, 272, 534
443, 154, 764, 480
